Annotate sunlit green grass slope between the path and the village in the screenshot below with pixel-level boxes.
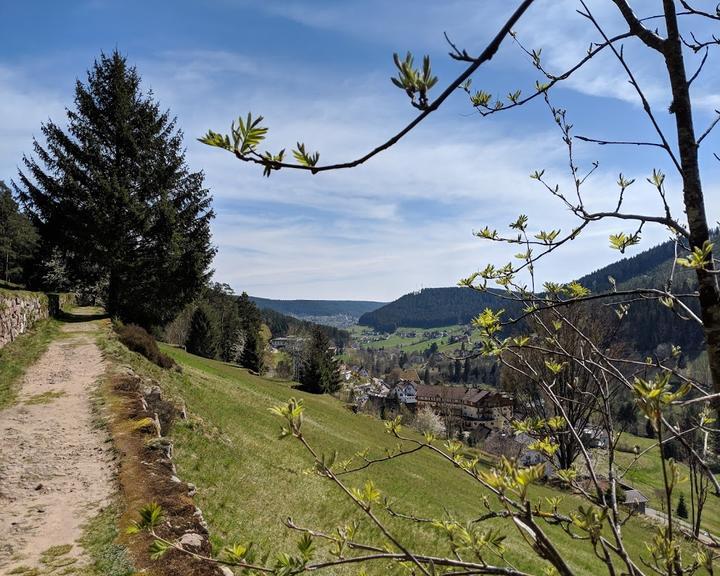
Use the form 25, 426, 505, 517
107, 347, 696, 574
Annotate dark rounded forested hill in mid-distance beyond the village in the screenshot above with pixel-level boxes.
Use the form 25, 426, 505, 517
358, 288, 511, 332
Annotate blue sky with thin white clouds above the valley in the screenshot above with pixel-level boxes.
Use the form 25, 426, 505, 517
0, 0, 720, 301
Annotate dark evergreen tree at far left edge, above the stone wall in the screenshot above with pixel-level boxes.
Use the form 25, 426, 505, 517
0, 180, 38, 283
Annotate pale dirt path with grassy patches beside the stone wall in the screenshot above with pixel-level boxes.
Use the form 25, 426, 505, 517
0, 312, 114, 575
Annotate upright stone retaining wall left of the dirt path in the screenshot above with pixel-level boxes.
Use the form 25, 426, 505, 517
0, 289, 74, 348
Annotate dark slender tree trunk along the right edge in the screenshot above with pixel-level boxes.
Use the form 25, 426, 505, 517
663, 0, 720, 412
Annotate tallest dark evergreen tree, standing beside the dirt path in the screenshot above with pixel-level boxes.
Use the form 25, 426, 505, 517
14, 51, 215, 327
